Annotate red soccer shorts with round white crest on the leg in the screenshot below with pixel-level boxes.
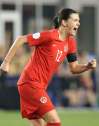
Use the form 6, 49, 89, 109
18, 84, 54, 119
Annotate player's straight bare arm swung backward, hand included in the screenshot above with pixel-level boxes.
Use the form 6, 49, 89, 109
0, 36, 27, 72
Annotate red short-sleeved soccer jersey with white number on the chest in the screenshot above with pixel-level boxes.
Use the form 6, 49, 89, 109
18, 29, 76, 89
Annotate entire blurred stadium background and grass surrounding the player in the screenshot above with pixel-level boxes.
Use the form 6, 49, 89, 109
0, 0, 99, 126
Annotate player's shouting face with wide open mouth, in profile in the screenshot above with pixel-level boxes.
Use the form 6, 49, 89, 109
66, 13, 80, 36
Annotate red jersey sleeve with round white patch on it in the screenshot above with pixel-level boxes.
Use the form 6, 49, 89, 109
27, 31, 51, 46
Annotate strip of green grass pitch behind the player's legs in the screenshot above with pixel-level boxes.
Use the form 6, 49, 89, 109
0, 109, 99, 126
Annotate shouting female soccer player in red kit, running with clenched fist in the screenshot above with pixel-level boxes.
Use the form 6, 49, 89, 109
0, 8, 96, 126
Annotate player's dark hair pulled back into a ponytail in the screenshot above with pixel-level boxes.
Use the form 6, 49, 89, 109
53, 8, 78, 28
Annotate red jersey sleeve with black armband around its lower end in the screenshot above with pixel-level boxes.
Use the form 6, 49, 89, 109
67, 38, 77, 62
